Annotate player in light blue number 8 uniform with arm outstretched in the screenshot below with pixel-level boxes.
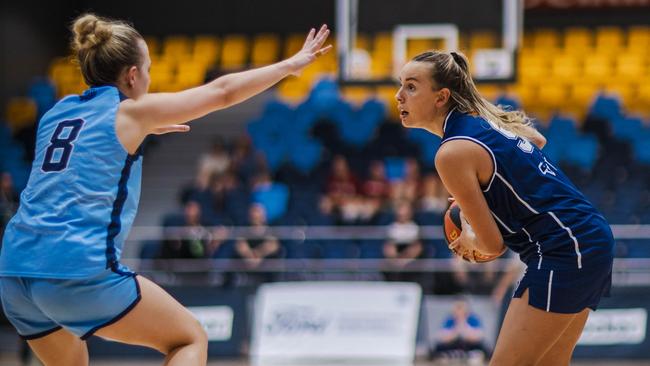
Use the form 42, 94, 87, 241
0, 14, 331, 366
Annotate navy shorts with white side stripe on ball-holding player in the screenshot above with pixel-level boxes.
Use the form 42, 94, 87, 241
514, 261, 612, 314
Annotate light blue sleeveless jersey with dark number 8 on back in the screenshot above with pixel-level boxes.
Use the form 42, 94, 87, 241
0, 86, 142, 279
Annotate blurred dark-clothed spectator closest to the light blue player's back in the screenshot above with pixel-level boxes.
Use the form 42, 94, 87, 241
161, 201, 225, 259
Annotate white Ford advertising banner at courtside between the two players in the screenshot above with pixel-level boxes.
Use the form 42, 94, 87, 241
251, 282, 421, 364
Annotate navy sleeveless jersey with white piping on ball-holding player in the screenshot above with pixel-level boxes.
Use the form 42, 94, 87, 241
442, 110, 614, 269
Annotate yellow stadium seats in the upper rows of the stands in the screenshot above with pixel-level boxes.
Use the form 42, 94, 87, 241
8, 26, 650, 132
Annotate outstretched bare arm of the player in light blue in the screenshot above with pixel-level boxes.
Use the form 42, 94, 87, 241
120, 25, 332, 134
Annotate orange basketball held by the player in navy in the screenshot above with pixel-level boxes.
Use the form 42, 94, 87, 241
443, 201, 507, 263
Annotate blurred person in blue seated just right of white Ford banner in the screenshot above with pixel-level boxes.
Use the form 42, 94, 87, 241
433, 300, 489, 365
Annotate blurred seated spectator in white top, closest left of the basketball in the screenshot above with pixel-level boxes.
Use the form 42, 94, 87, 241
384, 201, 422, 281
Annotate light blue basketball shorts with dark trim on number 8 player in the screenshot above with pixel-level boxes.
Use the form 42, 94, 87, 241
0, 269, 140, 340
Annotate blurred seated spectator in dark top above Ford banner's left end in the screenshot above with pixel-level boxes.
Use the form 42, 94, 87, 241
235, 204, 280, 268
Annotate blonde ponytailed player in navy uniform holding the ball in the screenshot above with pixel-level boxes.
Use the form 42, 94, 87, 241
396, 52, 614, 366
